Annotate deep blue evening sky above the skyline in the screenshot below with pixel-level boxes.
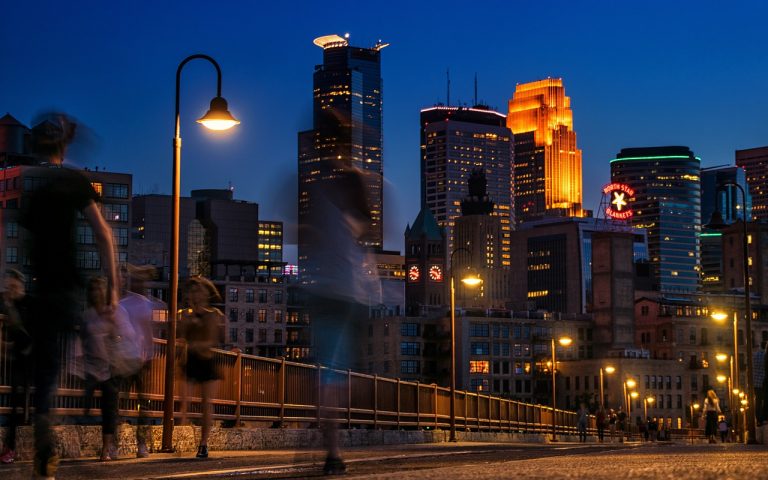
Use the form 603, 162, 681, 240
0, 0, 768, 260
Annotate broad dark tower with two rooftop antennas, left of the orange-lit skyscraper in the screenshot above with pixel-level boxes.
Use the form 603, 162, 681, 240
421, 106, 514, 267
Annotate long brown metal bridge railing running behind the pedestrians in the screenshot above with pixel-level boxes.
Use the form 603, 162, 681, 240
0, 336, 595, 434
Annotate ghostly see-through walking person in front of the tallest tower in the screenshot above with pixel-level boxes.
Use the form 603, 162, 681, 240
299, 160, 378, 475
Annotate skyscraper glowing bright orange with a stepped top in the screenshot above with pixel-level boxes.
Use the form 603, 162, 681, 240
507, 78, 583, 223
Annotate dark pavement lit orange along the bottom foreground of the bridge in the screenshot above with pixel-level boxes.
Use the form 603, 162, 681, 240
0, 442, 768, 480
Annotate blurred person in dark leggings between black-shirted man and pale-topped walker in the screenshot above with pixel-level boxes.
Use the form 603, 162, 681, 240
81, 277, 118, 462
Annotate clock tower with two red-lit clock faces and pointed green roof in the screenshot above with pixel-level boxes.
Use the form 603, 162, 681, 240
405, 207, 448, 316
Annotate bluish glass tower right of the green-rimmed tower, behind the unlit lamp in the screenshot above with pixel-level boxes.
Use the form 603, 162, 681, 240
700, 166, 752, 292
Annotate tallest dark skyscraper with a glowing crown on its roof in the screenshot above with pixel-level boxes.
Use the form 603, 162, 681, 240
299, 35, 387, 280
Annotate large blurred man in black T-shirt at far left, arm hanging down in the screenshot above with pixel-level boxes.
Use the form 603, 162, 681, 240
19, 114, 118, 478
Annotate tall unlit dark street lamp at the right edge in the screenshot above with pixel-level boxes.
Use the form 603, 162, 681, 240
706, 182, 757, 443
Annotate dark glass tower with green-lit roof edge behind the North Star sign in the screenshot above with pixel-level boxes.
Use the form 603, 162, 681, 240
611, 147, 701, 293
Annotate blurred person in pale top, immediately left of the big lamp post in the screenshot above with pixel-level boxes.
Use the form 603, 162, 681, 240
120, 264, 155, 458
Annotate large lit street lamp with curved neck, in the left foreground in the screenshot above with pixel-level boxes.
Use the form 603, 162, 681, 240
162, 54, 240, 452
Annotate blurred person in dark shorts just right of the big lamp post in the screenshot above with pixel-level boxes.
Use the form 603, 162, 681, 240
179, 276, 224, 458
